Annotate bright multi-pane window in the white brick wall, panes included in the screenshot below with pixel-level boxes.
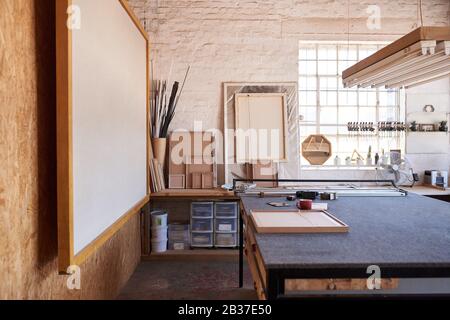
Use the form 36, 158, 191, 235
299, 42, 405, 166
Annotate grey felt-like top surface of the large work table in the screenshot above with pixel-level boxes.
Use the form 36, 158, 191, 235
242, 194, 450, 269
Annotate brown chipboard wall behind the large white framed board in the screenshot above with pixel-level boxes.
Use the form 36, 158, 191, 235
0, 0, 140, 299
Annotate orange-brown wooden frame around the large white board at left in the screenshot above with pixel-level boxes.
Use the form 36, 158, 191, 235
55, 0, 151, 274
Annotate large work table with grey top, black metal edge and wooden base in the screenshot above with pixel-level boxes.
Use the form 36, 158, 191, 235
241, 193, 450, 299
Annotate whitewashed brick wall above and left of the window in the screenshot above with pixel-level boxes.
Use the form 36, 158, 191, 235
129, 0, 450, 180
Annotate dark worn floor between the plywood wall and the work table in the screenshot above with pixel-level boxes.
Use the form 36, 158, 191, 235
118, 258, 257, 300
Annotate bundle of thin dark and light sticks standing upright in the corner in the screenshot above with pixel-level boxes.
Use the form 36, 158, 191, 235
150, 66, 191, 138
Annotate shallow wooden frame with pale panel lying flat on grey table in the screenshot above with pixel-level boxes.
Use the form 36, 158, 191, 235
251, 210, 349, 233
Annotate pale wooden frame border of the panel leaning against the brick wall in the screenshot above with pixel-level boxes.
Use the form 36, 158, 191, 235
234, 93, 288, 163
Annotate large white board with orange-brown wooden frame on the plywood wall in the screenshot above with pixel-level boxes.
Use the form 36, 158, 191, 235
56, 0, 149, 273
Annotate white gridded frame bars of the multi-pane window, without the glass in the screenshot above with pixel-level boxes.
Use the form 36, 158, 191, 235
298, 41, 406, 169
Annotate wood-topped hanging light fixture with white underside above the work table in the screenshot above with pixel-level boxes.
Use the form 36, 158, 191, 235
342, 27, 450, 89
